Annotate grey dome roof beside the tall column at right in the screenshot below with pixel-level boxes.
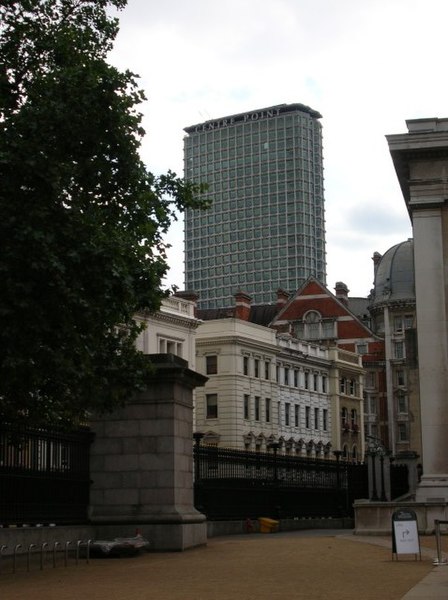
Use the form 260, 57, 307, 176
371, 239, 415, 306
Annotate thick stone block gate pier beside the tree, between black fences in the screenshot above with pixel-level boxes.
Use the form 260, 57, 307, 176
90, 354, 207, 550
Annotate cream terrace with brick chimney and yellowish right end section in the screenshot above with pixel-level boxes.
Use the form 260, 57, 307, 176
195, 293, 364, 460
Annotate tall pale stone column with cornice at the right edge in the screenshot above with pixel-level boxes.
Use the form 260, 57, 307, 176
387, 119, 448, 503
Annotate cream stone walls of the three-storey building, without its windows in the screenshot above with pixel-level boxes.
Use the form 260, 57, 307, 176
195, 319, 332, 455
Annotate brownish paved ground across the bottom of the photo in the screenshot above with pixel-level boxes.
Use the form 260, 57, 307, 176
0, 530, 448, 600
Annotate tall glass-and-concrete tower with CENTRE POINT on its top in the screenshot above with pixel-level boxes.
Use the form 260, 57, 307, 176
184, 104, 326, 308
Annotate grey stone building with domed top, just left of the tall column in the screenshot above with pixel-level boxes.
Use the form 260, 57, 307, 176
365, 239, 422, 456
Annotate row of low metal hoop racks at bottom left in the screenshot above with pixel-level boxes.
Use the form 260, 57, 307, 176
0, 540, 92, 574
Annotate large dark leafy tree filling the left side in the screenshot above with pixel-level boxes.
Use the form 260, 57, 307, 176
0, 0, 205, 423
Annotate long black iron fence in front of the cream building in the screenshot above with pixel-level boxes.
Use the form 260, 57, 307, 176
194, 444, 368, 519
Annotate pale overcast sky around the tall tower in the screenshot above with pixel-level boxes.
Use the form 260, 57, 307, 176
111, 0, 448, 296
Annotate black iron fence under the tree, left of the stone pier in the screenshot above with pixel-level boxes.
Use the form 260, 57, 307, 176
0, 423, 92, 526
